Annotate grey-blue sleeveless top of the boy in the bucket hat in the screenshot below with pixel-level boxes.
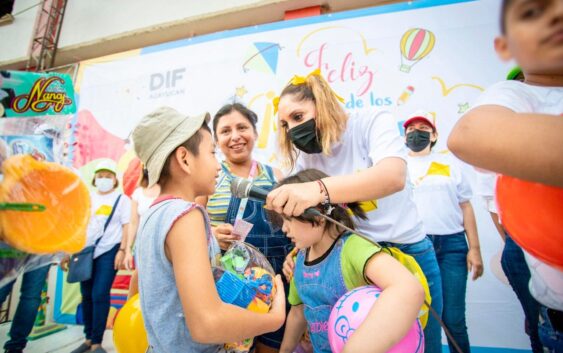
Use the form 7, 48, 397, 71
136, 199, 224, 353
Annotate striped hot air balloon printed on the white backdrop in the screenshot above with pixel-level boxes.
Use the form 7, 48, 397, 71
399, 28, 436, 73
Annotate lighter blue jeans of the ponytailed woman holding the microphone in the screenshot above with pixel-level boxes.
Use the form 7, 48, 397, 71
382, 237, 443, 353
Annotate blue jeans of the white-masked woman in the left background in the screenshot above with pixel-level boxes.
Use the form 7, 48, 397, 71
80, 244, 119, 344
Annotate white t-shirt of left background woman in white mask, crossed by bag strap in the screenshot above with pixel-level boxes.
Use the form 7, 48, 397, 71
86, 191, 131, 258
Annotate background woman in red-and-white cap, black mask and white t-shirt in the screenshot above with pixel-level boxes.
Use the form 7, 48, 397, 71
403, 111, 483, 353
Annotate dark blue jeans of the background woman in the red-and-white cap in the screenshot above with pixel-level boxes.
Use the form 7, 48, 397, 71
428, 232, 471, 353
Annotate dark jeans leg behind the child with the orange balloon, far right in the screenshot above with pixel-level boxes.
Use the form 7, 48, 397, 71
500, 234, 543, 353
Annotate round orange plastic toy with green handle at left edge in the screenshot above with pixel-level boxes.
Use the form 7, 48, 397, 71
0, 155, 90, 254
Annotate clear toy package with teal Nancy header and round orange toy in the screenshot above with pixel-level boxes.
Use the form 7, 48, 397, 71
0, 71, 90, 287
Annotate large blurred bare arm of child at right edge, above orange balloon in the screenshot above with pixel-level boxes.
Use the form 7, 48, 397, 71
448, 105, 563, 187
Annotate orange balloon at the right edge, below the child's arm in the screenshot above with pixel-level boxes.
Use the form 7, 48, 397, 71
496, 175, 563, 270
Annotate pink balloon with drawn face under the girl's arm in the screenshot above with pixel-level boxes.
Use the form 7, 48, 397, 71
328, 286, 424, 353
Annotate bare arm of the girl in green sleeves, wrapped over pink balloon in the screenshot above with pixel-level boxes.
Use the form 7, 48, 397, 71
343, 253, 424, 353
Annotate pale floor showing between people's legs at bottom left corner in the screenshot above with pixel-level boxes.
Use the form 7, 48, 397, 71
0, 323, 116, 353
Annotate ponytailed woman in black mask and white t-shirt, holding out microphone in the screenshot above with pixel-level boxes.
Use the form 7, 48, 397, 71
267, 70, 442, 353
